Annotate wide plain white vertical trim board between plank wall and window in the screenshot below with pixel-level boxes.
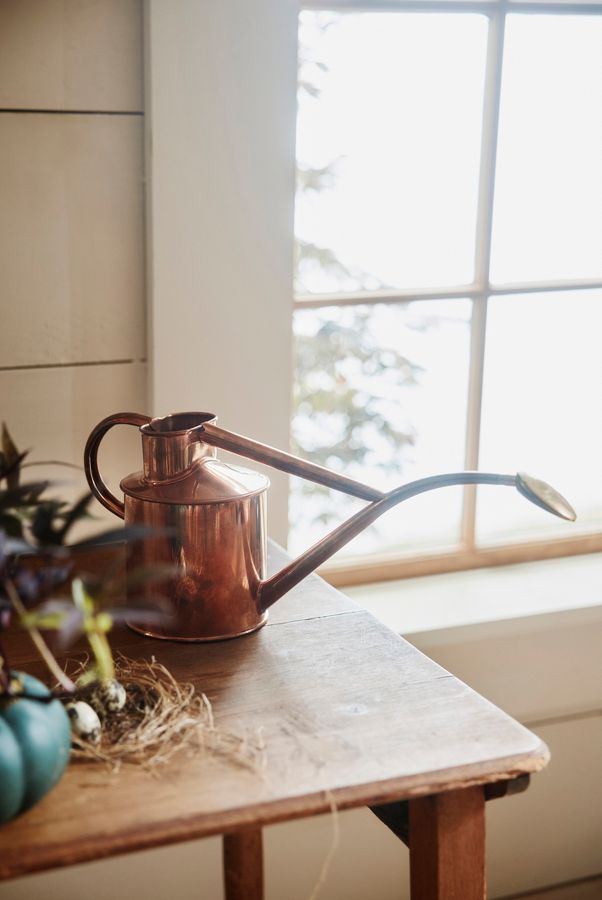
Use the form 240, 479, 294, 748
147, 0, 297, 542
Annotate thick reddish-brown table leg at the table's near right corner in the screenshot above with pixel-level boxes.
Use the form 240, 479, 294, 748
409, 787, 486, 900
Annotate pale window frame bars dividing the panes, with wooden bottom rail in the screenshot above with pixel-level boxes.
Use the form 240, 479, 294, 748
293, 0, 602, 586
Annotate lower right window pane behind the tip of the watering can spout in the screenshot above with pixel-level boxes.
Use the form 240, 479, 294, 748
477, 291, 602, 543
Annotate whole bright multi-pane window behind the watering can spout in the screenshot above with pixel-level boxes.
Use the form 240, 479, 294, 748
289, 0, 602, 584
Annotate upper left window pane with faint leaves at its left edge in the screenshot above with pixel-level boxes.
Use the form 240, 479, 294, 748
296, 11, 487, 293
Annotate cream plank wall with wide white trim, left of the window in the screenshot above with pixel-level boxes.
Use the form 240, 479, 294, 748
0, 0, 296, 541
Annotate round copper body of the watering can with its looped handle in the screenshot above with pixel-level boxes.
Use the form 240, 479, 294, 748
85, 413, 270, 641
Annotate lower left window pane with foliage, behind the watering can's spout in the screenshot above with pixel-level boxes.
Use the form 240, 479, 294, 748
289, 300, 470, 557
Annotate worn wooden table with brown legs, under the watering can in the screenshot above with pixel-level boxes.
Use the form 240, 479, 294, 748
0, 551, 548, 900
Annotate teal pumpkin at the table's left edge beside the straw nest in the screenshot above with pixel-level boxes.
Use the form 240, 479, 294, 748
0, 672, 71, 822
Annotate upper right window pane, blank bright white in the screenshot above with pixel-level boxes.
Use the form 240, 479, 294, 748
491, 15, 602, 283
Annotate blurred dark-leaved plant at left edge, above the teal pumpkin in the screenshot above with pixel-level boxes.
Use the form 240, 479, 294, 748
0, 424, 173, 696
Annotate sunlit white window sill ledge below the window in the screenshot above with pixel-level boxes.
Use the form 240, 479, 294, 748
344, 553, 602, 635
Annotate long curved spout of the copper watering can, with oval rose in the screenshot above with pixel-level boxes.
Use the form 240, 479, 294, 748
259, 472, 576, 610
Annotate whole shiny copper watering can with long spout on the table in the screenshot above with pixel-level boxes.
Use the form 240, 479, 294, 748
85, 412, 575, 641
